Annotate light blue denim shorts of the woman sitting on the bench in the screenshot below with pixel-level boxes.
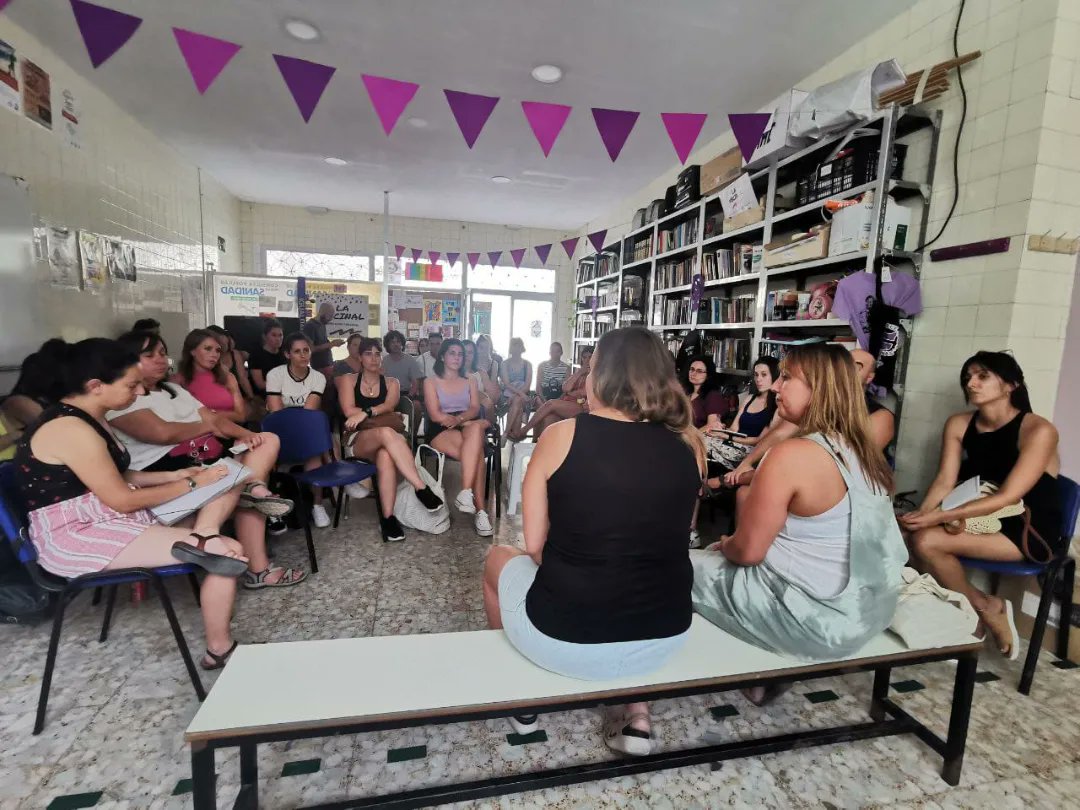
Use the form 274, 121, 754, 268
499, 554, 689, 680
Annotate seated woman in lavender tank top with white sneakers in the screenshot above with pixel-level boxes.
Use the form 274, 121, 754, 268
423, 338, 494, 537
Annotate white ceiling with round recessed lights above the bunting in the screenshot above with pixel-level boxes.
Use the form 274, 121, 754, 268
6, 0, 914, 229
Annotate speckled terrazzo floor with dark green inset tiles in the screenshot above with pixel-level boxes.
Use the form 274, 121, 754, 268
0, 471, 1080, 810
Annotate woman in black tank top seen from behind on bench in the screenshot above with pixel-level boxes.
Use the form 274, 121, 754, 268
484, 328, 704, 754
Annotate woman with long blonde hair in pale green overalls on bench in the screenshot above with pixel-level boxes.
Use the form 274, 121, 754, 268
690, 345, 907, 678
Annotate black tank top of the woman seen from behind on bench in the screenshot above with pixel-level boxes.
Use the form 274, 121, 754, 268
525, 414, 701, 644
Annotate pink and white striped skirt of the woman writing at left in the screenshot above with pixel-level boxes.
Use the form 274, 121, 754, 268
30, 492, 158, 579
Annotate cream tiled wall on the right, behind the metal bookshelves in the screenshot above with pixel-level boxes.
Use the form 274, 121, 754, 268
582, 0, 1080, 489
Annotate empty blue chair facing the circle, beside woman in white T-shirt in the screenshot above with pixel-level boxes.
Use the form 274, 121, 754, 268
262, 408, 375, 573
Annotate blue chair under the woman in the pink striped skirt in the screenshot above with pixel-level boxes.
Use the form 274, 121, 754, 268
0, 462, 206, 734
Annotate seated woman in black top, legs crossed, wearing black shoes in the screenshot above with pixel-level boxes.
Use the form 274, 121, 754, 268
336, 338, 443, 542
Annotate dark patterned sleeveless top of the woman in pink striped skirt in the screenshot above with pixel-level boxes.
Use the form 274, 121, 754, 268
15, 402, 132, 512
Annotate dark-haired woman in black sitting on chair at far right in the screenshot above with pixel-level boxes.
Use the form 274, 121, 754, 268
901, 352, 1068, 659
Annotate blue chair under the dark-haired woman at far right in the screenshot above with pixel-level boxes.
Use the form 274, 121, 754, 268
960, 475, 1080, 694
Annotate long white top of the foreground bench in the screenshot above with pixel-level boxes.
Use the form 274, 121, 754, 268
185, 616, 982, 742
